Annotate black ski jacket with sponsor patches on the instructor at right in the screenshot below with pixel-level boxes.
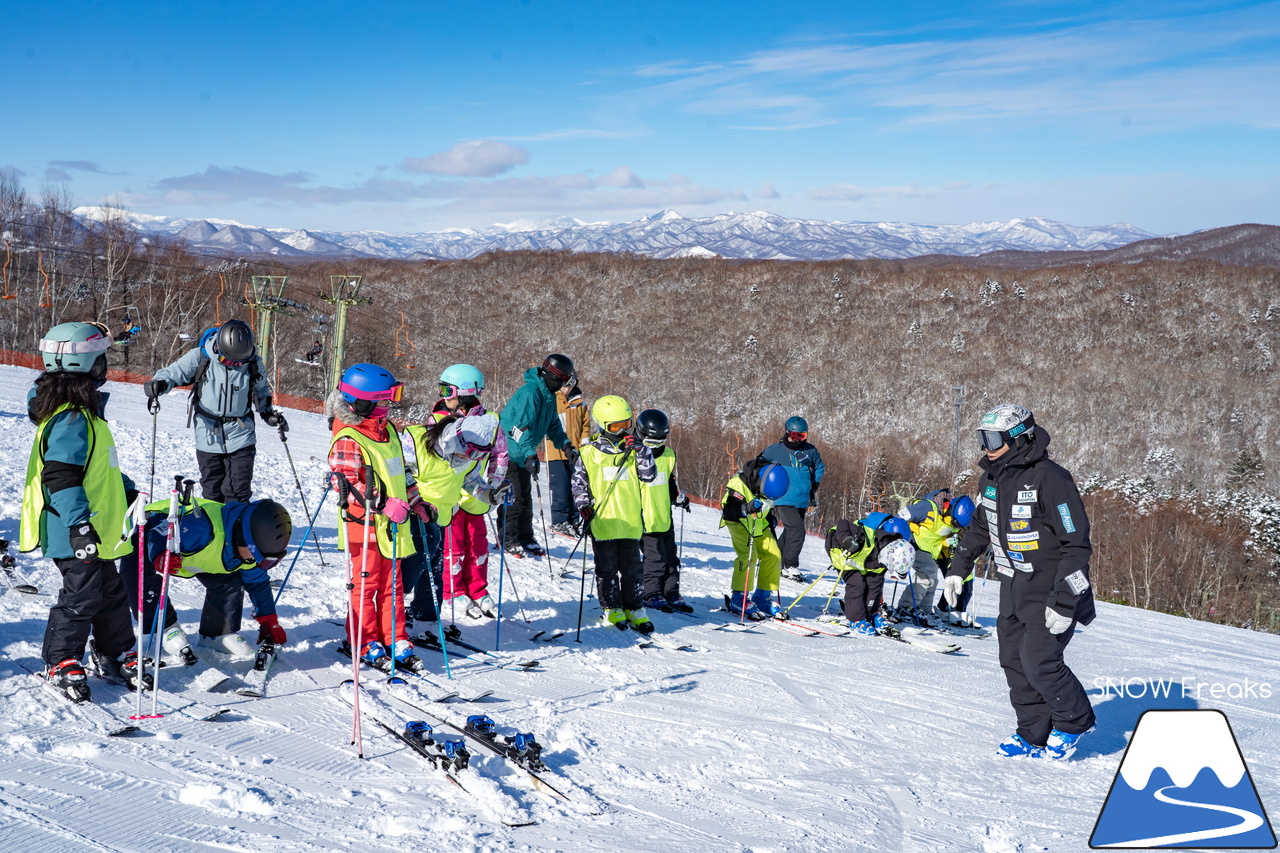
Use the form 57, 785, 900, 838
947, 427, 1097, 625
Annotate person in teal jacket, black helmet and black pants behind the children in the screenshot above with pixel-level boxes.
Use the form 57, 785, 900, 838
500, 352, 577, 557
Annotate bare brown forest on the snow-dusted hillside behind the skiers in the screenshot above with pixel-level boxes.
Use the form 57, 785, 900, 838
0, 184, 1280, 630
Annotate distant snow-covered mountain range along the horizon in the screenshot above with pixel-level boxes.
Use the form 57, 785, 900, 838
76, 207, 1155, 260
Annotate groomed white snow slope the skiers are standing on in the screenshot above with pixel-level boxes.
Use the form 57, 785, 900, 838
0, 368, 1280, 853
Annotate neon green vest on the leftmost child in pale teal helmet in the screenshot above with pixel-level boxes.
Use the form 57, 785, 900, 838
18, 406, 133, 560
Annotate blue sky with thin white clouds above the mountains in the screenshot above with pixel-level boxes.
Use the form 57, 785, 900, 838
10, 0, 1280, 233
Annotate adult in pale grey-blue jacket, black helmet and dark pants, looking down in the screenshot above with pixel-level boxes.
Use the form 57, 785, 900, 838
142, 320, 289, 503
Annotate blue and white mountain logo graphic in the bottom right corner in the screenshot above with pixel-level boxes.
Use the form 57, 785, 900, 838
1089, 711, 1276, 849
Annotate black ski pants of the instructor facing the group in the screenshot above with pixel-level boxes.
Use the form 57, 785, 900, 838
996, 584, 1093, 747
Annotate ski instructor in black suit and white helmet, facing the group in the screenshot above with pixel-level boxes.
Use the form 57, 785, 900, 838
943, 403, 1096, 758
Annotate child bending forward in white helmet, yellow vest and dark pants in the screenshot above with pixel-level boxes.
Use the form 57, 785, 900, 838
827, 519, 915, 634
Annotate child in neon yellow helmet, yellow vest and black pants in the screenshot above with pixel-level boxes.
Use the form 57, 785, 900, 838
572, 394, 657, 634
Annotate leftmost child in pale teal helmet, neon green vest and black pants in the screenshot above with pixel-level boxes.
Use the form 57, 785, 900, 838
18, 323, 150, 702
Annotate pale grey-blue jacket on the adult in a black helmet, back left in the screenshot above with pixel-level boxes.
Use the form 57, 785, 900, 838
155, 341, 271, 453
